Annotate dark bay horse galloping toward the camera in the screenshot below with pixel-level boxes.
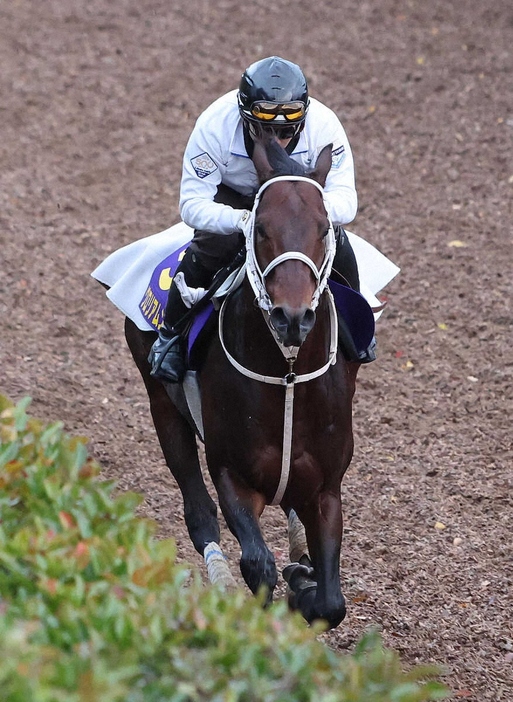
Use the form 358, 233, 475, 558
125, 141, 359, 627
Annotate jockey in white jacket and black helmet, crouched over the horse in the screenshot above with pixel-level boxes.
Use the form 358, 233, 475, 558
148, 56, 375, 383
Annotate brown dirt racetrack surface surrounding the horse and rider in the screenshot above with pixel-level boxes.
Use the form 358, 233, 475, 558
0, 0, 513, 702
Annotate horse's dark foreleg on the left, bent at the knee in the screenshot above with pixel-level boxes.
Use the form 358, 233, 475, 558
214, 470, 278, 602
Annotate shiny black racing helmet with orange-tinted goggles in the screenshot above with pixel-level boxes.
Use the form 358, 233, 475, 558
237, 56, 309, 138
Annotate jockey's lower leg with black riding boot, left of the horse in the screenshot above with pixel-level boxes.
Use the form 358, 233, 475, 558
148, 249, 213, 383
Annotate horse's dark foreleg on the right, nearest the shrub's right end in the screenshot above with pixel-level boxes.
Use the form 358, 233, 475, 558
296, 491, 346, 628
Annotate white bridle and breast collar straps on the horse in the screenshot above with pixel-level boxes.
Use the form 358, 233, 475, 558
219, 175, 338, 505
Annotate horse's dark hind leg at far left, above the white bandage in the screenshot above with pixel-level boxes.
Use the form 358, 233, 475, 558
125, 319, 220, 556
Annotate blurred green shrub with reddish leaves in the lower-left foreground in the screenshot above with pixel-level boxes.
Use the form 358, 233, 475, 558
0, 396, 446, 702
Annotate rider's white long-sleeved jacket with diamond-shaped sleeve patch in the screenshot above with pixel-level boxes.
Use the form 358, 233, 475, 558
180, 90, 357, 234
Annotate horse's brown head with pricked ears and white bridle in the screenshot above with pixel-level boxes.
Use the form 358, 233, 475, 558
248, 137, 335, 347
